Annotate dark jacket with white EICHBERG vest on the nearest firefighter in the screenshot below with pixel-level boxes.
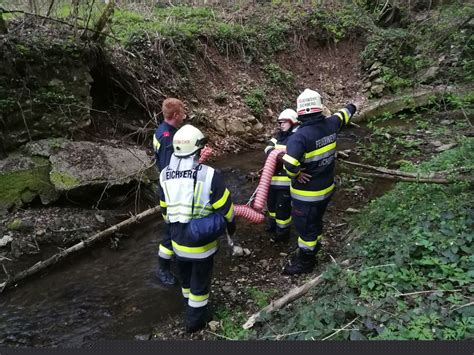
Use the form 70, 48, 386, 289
160, 154, 235, 259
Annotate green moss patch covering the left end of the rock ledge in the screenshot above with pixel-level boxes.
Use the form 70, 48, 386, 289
0, 158, 54, 208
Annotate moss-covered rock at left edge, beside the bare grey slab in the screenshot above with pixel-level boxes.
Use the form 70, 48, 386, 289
0, 155, 57, 211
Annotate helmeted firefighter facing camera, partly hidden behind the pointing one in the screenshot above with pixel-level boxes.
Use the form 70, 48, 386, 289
265, 109, 299, 242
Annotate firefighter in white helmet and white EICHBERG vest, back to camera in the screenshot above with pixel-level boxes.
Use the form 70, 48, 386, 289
160, 125, 236, 333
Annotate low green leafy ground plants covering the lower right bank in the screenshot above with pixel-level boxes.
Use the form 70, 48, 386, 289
248, 138, 474, 340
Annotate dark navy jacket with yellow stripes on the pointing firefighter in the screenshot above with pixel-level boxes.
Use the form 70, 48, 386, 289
283, 104, 356, 202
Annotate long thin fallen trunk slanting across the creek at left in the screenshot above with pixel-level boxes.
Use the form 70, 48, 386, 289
0, 206, 161, 293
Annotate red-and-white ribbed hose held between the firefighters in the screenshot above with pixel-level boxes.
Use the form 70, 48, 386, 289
199, 145, 285, 224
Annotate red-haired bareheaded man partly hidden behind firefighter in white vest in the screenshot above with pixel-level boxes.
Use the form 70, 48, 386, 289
153, 98, 186, 286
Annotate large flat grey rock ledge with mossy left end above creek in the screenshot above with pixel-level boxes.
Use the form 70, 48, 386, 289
0, 139, 158, 213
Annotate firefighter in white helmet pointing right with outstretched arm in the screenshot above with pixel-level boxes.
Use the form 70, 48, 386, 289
283, 89, 356, 275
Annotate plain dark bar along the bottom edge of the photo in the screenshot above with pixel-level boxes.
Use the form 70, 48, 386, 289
0, 340, 474, 355
